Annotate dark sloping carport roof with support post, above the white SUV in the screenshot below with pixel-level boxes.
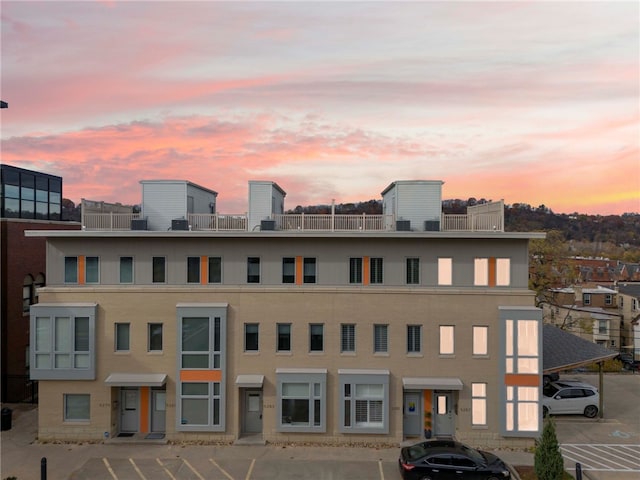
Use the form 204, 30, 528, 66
542, 325, 618, 418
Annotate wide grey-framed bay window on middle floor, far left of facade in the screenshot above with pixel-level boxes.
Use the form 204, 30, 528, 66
30, 304, 96, 380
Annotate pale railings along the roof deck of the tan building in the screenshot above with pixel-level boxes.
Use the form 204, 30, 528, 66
82, 211, 504, 232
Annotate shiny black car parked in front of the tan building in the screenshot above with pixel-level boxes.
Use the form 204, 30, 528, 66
398, 440, 511, 480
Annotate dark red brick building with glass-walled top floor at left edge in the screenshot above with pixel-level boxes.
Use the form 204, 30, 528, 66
0, 165, 80, 403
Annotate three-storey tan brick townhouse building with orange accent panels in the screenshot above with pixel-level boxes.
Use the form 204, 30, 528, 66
26, 180, 544, 447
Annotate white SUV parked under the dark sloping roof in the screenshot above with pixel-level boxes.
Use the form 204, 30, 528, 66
542, 380, 600, 418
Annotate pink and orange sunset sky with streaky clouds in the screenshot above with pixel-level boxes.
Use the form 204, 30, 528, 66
0, 0, 640, 215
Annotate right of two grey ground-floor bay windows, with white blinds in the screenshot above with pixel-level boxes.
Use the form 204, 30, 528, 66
338, 370, 389, 434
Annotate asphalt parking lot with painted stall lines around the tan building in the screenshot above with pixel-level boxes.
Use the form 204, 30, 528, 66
0, 374, 640, 480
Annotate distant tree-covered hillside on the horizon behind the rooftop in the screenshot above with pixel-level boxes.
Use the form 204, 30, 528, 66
287, 198, 640, 247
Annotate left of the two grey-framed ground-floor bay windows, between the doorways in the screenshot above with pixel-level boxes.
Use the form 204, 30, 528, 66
276, 368, 327, 433
